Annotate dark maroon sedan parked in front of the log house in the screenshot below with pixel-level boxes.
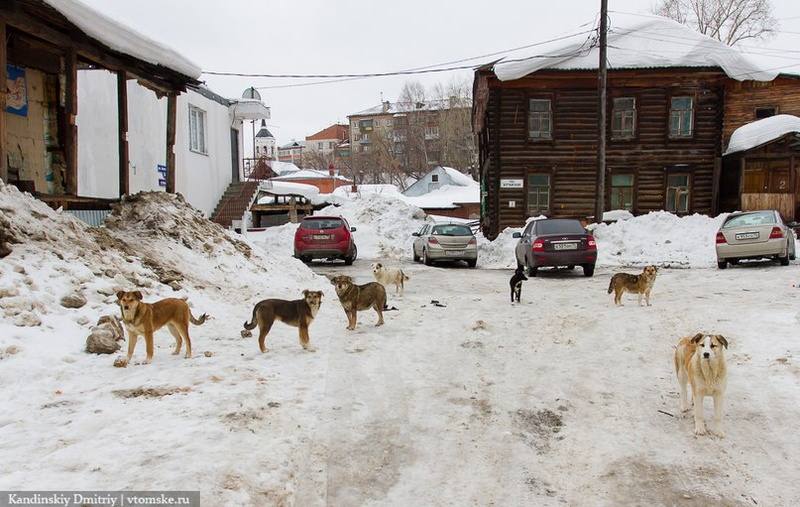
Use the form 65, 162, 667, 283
512, 218, 597, 276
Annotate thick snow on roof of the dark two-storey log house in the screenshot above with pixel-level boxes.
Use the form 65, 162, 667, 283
494, 14, 778, 81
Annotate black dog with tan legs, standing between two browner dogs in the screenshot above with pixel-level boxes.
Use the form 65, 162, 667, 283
242, 289, 322, 354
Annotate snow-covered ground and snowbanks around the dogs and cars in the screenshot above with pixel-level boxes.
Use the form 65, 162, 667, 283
0, 184, 800, 506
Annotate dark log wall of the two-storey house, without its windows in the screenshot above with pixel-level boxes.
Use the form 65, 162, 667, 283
475, 69, 724, 238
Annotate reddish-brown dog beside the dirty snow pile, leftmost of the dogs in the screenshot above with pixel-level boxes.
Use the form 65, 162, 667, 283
117, 290, 208, 363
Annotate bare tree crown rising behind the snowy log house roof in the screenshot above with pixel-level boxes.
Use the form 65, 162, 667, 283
653, 0, 778, 46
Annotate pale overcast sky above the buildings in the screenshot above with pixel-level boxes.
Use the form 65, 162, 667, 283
80, 0, 800, 145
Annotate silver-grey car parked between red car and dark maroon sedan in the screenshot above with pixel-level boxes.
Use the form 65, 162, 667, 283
412, 224, 478, 268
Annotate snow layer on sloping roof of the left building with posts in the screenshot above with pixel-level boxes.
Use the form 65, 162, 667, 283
44, 0, 202, 79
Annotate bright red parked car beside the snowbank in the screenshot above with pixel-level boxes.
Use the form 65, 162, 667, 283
294, 215, 358, 266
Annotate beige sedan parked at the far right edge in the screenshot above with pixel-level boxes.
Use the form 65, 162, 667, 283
717, 210, 797, 269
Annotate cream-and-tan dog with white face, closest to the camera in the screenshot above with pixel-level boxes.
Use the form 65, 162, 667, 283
675, 333, 728, 438
